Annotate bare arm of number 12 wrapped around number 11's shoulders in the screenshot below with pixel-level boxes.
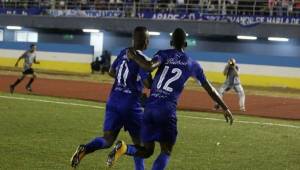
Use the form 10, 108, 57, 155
127, 48, 160, 72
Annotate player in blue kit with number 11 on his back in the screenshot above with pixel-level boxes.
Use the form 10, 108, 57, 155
71, 27, 152, 170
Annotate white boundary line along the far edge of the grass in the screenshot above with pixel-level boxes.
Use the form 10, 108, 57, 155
0, 95, 300, 129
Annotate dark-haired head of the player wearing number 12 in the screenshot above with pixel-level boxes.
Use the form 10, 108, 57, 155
170, 28, 187, 50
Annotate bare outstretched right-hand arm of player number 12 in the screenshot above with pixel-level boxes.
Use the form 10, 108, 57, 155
202, 80, 233, 125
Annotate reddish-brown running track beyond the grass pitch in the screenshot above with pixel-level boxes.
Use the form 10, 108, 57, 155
0, 75, 300, 120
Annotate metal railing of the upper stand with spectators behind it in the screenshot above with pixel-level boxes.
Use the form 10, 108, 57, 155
0, 0, 300, 17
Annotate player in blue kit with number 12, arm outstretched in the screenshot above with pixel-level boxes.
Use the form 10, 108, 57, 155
107, 28, 233, 170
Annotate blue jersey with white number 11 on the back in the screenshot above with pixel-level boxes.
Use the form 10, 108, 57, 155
107, 48, 149, 108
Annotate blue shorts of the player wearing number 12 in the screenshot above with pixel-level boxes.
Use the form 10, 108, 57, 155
142, 103, 178, 144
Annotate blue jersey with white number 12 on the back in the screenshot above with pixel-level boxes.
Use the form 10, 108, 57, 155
149, 49, 206, 105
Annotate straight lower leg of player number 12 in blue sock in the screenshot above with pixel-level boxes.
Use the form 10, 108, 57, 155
152, 142, 174, 170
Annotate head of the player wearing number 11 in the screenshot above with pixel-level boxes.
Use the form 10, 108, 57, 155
133, 26, 149, 50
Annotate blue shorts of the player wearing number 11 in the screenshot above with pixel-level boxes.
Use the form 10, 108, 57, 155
103, 105, 143, 137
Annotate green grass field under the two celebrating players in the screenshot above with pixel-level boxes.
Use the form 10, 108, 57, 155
0, 93, 300, 170
